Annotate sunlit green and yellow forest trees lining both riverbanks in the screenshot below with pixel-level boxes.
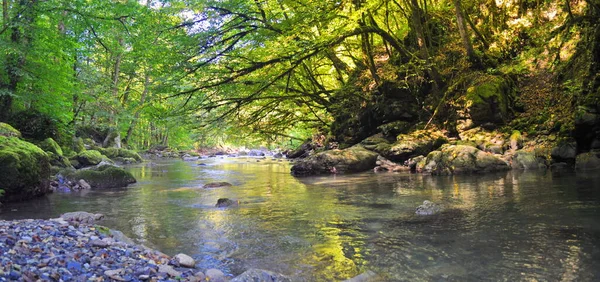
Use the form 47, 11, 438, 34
0, 0, 600, 152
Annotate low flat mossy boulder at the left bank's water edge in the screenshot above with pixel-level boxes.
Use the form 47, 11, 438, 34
61, 165, 136, 188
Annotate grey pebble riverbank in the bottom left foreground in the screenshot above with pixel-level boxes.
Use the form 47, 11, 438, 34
0, 218, 290, 281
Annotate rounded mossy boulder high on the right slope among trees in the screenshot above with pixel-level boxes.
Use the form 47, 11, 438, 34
464, 75, 515, 125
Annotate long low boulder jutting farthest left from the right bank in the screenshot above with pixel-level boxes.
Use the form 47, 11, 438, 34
292, 146, 377, 176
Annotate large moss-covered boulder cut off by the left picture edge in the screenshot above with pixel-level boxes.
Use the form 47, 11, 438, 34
0, 136, 50, 201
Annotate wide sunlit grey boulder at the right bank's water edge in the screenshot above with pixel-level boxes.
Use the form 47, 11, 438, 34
421, 145, 510, 175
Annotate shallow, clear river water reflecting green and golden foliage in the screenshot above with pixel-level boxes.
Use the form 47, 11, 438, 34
0, 158, 600, 281
